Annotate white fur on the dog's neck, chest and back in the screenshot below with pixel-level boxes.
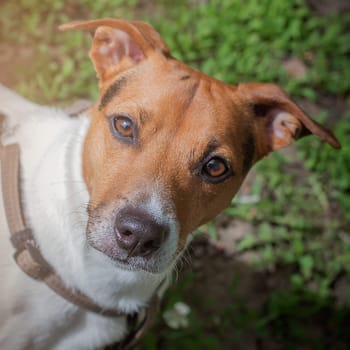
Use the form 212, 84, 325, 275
0, 85, 177, 350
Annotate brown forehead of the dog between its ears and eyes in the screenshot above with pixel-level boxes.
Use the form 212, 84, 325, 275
95, 60, 254, 175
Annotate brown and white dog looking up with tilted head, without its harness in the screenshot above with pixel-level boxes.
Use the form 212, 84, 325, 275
0, 18, 340, 350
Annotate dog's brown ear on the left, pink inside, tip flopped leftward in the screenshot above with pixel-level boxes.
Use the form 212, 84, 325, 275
59, 18, 170, 81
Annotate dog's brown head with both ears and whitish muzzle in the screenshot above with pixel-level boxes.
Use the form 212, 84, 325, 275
60, 19, 339, 273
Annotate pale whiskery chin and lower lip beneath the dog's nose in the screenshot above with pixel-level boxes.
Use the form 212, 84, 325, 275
88, 240, 172, 274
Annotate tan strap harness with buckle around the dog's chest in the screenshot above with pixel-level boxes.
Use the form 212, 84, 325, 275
0, 114, 162, 350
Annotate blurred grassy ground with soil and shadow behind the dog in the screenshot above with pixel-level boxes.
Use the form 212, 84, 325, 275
0, 0, 350, 350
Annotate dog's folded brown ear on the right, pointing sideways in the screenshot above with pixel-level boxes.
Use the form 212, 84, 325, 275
236, 83, 341, 158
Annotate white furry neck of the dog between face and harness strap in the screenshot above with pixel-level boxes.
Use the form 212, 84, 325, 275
24, 108, 166, 312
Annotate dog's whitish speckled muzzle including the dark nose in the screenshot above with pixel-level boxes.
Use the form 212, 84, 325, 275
87, 197, 179, 273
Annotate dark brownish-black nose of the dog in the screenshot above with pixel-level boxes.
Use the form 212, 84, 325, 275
114, 207, 168, 257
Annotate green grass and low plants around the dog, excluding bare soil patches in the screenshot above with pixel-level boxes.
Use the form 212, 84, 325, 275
0, 0, 350, 350
